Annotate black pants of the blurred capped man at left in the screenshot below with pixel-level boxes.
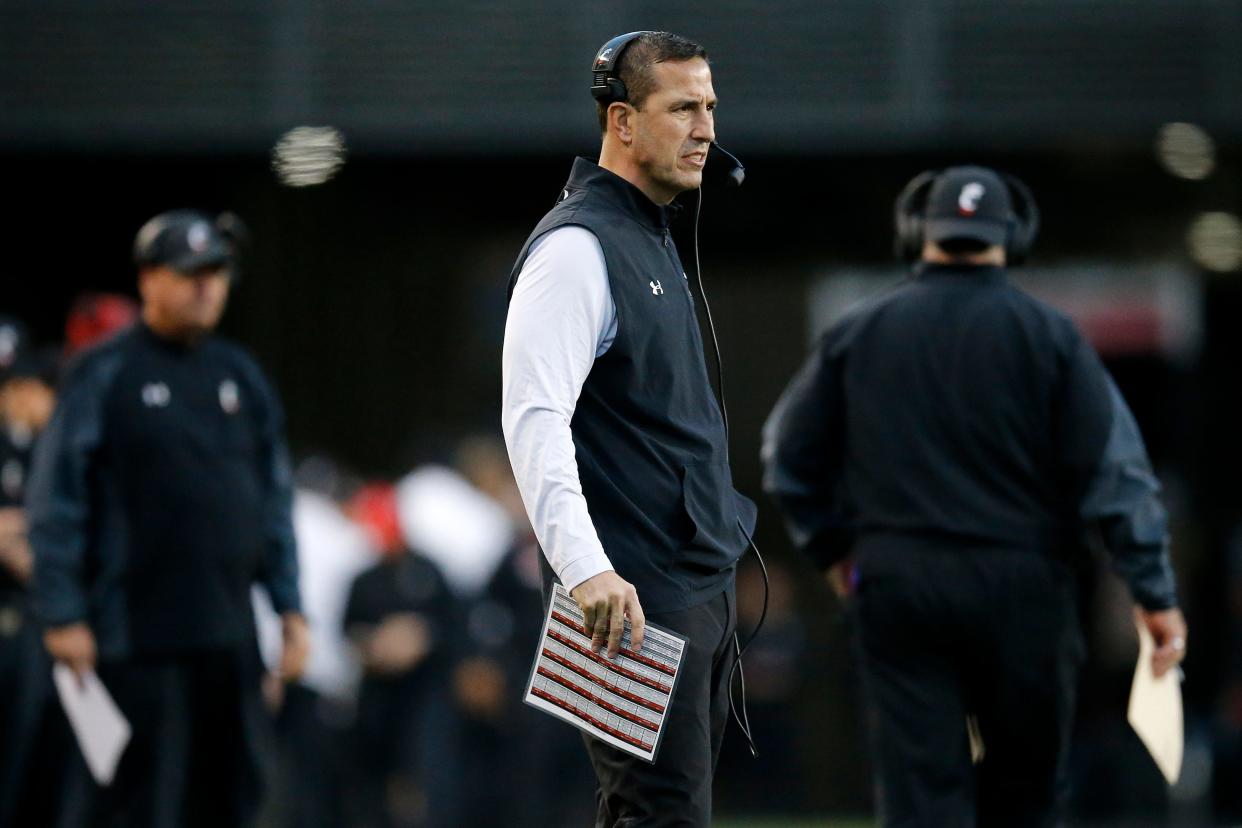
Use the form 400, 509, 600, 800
80, 649, 272, 828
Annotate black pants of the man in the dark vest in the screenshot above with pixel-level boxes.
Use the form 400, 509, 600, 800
586, 585, 738, 828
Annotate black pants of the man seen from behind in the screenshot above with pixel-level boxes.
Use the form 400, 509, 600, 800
853, 541, 1084, 828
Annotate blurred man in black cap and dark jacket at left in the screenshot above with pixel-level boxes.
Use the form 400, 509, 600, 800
27, 210, 308, 828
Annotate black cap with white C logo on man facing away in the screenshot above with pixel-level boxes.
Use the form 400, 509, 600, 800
924, 166, 1013, 245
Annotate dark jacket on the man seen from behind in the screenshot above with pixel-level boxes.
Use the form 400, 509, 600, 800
764, 266, 1176, 610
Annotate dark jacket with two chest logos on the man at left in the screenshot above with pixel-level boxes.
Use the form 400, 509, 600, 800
27, 325, 299, 658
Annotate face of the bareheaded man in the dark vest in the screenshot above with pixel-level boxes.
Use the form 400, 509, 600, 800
630, 57, 715, 204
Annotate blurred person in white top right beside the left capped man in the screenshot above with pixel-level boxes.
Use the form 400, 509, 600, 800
252, 456, 372, 828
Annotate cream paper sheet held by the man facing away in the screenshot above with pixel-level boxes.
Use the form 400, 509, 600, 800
1126, 622, 1185, 785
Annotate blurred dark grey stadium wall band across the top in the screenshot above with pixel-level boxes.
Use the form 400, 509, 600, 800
0, 0, 1242, 155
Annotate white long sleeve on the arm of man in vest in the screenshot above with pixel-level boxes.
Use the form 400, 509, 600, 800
501, 226, 617, 590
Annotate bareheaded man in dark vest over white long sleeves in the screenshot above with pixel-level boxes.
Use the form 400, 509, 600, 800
503, 32, 755, 826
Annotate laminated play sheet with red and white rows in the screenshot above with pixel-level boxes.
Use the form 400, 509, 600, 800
525, 583, 686, 762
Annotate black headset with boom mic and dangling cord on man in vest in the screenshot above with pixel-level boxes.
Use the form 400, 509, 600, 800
591, 31, 768, 757
